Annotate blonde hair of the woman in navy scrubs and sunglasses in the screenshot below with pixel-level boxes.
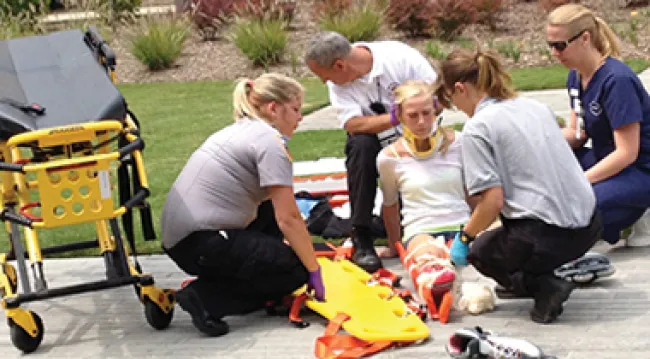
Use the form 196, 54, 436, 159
548, 4, 621, 57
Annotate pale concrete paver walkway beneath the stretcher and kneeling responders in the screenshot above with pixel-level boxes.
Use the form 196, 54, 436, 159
0, 244, 650, 359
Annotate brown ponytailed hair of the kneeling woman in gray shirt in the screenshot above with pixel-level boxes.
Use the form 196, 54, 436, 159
437, 48, 517, 107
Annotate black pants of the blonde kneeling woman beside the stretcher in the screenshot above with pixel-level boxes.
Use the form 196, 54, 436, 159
166, 201, 308, 319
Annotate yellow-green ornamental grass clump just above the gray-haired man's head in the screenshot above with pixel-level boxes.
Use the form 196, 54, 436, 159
319, 2, 383, 42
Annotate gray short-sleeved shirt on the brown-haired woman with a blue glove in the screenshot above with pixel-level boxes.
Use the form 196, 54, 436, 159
462, 97, 596, 228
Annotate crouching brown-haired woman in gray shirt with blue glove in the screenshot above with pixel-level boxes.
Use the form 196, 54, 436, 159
440, 49, 601, 323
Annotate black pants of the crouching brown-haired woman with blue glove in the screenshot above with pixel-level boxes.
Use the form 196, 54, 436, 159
468, 214, 602, 296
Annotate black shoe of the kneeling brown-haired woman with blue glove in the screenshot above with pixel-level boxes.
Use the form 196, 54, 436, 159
530, 275, 575, 324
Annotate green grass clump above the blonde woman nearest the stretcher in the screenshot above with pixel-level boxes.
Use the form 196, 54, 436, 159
229, 19, 288, 67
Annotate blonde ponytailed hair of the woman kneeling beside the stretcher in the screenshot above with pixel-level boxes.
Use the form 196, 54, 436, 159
232, 73, 305, 121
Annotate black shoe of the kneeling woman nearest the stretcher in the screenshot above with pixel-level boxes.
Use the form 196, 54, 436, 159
176, 287, 230, 337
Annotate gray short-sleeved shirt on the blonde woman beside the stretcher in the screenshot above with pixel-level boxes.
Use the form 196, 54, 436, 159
161, 119, 293, 249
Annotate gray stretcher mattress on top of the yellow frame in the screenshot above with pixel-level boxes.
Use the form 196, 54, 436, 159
0, 30, 126, 140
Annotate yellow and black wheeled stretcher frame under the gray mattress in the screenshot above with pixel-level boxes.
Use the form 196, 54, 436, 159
0, 27, 175, 353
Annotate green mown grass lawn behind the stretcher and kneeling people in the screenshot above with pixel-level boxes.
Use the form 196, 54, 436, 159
0, 60, 649, 255
